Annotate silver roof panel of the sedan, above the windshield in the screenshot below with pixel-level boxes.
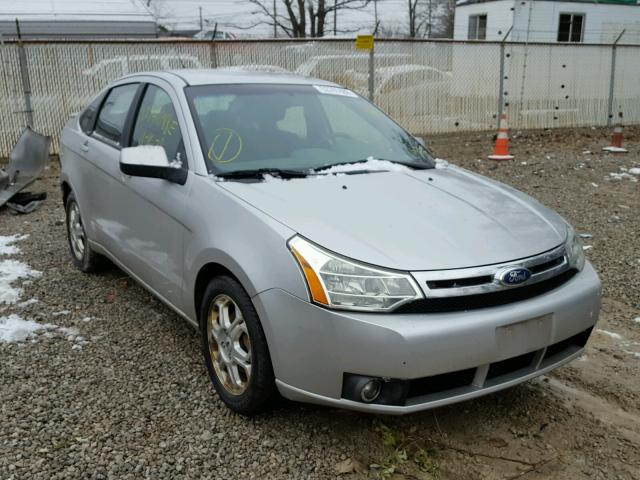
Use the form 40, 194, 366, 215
121, 68, 338, 86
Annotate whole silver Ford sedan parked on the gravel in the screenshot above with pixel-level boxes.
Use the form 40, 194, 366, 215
61, 70, 601, 415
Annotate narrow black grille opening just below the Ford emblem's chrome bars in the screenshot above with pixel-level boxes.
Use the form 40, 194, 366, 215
394, 270, 576, 313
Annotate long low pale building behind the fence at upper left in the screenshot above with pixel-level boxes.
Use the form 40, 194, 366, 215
0, 0, 156, 39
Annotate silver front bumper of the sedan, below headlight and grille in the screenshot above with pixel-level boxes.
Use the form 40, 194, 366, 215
254, 263, 601, 414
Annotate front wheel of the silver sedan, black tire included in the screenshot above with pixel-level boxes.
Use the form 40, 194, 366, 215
199, 276, 277, 416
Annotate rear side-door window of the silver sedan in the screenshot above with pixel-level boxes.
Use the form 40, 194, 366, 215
94, 83, 139, 147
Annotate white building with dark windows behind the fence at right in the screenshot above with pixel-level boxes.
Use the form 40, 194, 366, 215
454, 0, 640, 44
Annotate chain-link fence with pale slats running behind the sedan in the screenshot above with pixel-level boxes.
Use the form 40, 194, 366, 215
0, 40, 640, 156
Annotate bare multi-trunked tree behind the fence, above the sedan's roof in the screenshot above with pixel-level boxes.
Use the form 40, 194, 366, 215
247, 0, 371, 38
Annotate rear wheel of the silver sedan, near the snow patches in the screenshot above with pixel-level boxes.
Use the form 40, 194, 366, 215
65, 192, 106, 273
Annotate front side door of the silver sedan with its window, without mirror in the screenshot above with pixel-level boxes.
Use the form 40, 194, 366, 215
118, 83, 193, 310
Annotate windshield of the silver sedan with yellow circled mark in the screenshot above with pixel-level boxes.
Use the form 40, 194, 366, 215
186, 84, 434, 174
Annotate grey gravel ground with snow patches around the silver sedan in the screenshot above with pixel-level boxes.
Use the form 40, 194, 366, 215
0, 125, 640, 480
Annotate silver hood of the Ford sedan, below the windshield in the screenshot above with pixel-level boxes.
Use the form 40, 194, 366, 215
219, 166, 566, 271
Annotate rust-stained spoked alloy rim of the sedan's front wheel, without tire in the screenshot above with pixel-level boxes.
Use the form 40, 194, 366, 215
207, 294, 251, 395
